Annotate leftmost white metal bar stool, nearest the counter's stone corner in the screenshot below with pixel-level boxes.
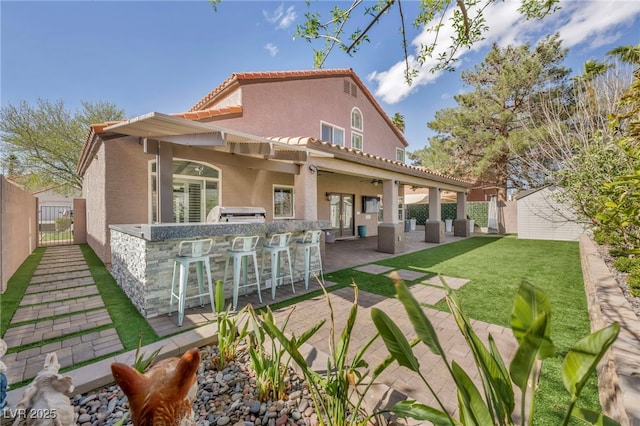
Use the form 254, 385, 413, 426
169, 238, 216, 327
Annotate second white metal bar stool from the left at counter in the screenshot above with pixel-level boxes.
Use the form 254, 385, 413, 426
222, 236, 262, 310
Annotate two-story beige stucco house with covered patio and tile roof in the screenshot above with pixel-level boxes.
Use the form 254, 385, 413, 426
77, 69, 471, 263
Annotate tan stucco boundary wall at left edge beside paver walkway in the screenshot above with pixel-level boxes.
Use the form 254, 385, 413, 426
0, 175, 38, 293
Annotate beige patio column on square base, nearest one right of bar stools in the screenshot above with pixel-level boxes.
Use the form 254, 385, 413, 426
378, 180, 404, 253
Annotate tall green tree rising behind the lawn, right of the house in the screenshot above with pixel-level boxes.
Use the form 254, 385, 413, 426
410, 34, 570, 199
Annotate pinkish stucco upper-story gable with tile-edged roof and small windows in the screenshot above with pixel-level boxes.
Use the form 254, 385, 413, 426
190, 69, 408, 162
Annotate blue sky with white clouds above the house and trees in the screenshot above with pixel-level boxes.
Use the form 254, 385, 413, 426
0, 0, 640, 151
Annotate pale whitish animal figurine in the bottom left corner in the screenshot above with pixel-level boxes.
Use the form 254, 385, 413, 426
11, 352, 77, 426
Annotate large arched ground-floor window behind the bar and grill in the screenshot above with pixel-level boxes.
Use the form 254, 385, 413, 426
149, 159, 220, 223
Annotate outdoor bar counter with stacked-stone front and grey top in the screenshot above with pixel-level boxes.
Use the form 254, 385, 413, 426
109, 220, 331, 318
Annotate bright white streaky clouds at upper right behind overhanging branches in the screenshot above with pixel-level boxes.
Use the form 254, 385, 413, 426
369, 0, 640, 104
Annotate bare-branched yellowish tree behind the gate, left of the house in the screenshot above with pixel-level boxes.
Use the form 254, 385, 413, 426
0, 99, 124, 190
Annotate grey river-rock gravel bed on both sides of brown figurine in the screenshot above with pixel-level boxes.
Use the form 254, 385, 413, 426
71, 342, 318, 426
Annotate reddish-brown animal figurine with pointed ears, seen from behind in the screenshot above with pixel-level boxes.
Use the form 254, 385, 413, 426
111, 348, 200, 426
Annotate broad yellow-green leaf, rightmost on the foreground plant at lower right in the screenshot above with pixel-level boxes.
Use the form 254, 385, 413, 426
562, 322, 620, 398
